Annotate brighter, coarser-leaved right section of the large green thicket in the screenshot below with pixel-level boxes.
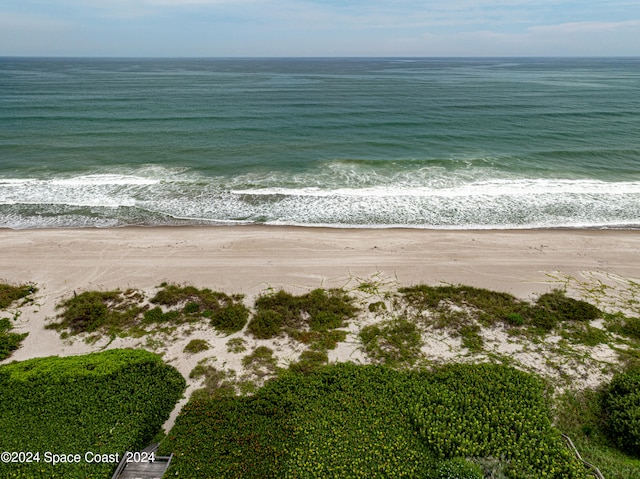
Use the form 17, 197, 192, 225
412, 364, 582, 479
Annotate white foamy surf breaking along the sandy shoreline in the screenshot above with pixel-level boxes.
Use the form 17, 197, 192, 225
0, 165, 640, 229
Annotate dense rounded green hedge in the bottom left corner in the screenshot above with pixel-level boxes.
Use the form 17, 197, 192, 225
0, 350, 185, 479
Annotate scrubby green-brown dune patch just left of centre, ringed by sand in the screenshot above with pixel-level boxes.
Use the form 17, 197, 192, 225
248, 289, 357, 339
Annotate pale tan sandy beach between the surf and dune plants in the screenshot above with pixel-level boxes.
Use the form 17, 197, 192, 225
0, 226, 640, 432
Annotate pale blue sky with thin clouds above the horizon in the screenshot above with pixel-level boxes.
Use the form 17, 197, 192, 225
0, 0, 640, 57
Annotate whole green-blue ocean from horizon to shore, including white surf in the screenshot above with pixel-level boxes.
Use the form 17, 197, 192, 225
0, 58, 640, 229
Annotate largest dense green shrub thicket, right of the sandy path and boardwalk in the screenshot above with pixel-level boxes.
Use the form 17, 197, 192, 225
161, 364, 587, 479
